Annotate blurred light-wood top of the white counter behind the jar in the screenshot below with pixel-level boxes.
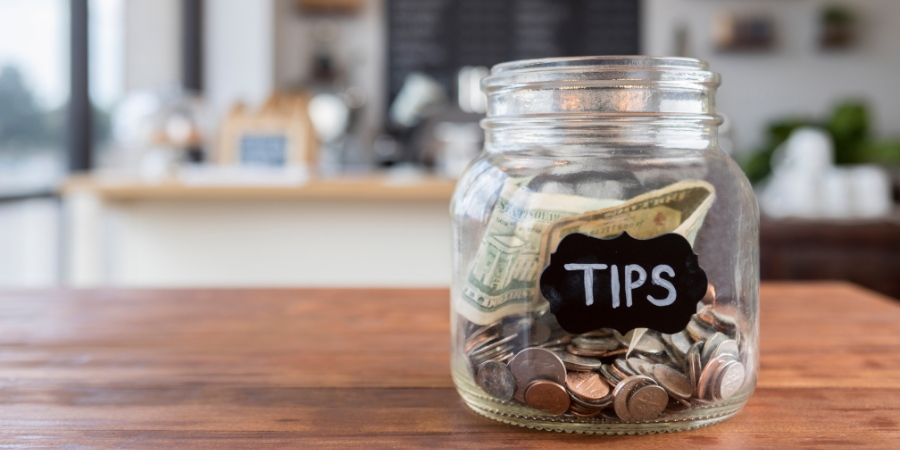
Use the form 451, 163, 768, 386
60, 175, 456, 200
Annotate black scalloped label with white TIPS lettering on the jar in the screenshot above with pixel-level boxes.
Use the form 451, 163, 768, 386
540, 233, 707, 334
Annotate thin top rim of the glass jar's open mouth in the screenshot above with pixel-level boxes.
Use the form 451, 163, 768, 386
491, 55, 709, 76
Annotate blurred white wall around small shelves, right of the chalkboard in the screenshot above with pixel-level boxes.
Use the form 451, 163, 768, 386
642, 0, 900, 155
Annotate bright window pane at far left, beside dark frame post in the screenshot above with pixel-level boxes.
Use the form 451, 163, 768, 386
0, 0, 69, 195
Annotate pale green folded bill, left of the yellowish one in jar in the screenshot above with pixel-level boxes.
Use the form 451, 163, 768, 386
456, 177, 622, 325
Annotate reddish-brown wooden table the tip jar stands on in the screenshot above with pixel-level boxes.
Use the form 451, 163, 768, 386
0, 283, 900, 449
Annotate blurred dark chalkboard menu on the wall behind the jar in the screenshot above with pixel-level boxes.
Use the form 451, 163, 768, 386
387, 0, 640, 99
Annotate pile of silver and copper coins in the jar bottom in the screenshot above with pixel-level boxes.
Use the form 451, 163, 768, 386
461, 288, 746, 422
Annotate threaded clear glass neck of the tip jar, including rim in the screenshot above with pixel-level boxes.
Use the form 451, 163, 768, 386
482, 56, 721, 151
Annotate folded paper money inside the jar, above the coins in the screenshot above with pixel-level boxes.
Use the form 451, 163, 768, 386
456, 178, 715, 325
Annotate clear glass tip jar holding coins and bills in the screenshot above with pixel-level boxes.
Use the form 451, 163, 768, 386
451, 56, 759, 434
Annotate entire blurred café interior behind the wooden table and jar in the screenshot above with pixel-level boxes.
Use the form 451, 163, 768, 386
0, 0, 900, 297
